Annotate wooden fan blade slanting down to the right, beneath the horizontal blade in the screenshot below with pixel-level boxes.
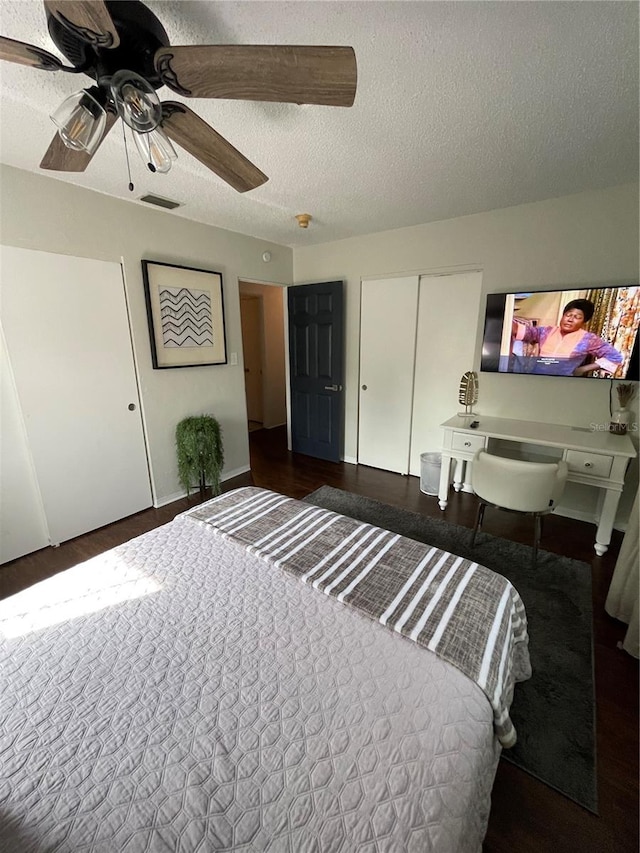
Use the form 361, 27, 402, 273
161, 101, 269, 193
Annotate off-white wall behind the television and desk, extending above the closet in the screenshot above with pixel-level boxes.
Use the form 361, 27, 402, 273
294, 184, 638, 517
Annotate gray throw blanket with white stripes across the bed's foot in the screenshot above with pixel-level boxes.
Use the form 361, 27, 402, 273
183, 487, 531, 747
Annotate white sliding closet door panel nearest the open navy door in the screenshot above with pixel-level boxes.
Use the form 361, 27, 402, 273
358, 276, 418, 474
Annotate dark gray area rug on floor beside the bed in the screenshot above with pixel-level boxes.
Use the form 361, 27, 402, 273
304, 486, 597, 814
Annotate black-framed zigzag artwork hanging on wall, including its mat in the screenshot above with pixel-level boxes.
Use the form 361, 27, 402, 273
142, 259, 227, 370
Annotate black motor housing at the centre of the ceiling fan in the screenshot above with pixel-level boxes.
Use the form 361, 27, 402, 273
47, 0, 169, 89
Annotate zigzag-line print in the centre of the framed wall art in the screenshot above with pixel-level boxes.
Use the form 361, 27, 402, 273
158, 287, 213, 349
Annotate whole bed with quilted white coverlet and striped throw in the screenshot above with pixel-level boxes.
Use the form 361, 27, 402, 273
0, 487, 530, 853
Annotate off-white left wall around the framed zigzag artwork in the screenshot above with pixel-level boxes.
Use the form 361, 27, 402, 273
0, 166, 292, 504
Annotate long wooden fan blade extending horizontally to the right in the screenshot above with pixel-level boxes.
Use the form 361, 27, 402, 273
154, 45, 358, 107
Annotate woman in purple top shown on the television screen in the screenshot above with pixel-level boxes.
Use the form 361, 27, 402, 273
512, 299, 622, 376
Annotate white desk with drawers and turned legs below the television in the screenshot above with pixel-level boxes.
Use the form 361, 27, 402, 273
438, 415, 636, 556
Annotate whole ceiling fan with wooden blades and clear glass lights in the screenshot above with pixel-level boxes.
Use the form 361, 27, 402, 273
0, 0, 357, 192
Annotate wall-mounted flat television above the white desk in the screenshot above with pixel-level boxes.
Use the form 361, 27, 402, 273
481, 285, 640, 381
